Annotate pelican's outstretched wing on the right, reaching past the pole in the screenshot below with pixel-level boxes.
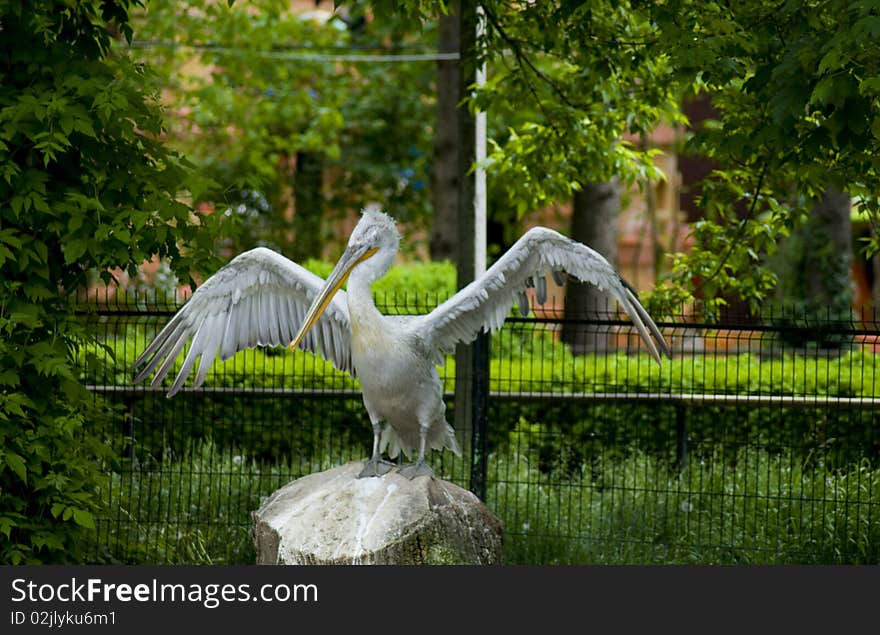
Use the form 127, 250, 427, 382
413, 227, 670, 364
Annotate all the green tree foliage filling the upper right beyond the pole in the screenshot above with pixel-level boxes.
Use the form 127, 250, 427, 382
362, 0, 880, 316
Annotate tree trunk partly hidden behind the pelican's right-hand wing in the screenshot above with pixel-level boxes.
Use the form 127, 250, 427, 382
562, 179, 620, 355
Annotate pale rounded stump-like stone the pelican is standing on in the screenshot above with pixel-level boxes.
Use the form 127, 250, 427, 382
253, 462, 503, 564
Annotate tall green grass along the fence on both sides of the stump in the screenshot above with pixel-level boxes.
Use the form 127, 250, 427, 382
91, 439, 880, 565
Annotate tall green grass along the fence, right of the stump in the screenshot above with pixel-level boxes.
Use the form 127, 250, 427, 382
487, 450, 880, 565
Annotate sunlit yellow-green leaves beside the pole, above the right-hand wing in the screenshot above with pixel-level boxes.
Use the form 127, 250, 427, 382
474, 2, 684, 214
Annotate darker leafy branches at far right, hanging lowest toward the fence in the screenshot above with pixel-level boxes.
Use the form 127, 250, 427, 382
641, 0, 880, 314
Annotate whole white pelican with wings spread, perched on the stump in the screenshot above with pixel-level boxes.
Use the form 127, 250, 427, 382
134, 209, 670, 479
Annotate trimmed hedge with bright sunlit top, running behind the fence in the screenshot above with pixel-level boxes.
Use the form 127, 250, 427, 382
80, 306, 880, 469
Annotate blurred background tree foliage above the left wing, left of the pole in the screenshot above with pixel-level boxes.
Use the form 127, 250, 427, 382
135, 0, 434, 256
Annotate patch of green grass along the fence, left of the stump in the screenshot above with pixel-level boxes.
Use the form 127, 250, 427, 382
91, 441, 303, 564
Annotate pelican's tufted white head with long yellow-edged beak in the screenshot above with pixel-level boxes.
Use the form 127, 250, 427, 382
290, 206, 400, 350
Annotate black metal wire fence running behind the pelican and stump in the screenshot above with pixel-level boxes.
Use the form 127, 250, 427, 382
81, 290, 880, 564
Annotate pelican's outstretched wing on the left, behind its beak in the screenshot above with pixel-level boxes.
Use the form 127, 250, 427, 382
134, 247, 354, 397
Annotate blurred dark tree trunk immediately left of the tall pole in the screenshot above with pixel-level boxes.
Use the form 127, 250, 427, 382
431, 2, 461, 262
